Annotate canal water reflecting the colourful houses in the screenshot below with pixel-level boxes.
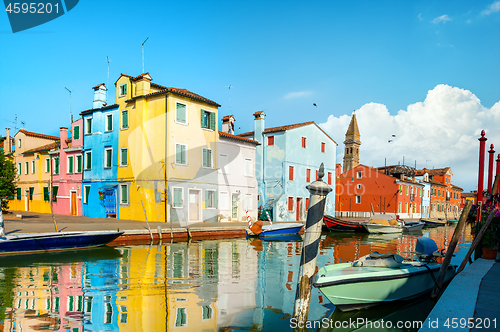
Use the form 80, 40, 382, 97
0, 226, 471, 332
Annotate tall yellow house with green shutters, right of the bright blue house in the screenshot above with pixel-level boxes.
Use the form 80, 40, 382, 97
115, 73, 220, 225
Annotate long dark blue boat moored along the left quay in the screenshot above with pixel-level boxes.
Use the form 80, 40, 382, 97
0, 231, 123, 255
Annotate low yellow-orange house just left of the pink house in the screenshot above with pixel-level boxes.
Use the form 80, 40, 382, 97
9, 130, 59, 213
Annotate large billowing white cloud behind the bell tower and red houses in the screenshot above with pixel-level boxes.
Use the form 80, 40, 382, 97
321, 84, 500, 191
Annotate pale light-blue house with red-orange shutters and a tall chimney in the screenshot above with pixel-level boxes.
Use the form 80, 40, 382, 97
239, 111, 337, 221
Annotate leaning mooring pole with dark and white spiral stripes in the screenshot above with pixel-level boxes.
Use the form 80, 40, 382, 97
293, 163, 332, 322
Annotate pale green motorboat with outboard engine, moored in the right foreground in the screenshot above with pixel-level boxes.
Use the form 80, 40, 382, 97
313, 237, 456, 311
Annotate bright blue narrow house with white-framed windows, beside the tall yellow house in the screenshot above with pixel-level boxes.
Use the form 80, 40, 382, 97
80, 84, 120, 218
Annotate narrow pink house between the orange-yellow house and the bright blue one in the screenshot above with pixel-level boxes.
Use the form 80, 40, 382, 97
50, 119, 83, 216
